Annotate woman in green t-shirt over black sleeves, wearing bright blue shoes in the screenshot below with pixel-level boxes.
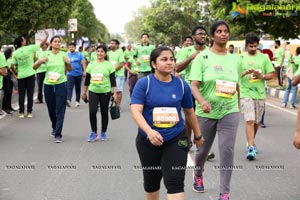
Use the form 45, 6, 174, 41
82, 44, 117, 142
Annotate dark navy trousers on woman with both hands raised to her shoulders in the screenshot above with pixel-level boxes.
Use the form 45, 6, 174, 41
44, 83, 67, 138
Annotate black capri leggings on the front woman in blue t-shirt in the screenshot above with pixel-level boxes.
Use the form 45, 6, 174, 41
136, 130, 188, 194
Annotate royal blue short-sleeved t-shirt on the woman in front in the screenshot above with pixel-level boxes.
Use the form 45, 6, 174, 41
130, 74, 193, 141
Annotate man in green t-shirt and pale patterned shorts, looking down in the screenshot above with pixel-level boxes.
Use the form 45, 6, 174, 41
240, 32, 274, 160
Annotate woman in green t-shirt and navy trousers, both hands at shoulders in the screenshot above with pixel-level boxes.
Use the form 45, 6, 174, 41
33, 36, 72, 143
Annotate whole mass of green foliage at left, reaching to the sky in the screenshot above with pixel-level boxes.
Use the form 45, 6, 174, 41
0, 0, 110, 44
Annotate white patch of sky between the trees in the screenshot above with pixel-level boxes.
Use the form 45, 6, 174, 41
90, 0, 150, 33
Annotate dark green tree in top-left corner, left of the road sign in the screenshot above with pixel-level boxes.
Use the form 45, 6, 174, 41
0, 0, 76, 42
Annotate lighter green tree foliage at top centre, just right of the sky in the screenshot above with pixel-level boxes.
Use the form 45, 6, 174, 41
125, 0, 213, 45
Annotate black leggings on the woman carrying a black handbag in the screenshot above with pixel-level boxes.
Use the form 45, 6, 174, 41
89, 91, 111, 133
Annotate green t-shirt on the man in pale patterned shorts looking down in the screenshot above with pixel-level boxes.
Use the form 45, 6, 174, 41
240, 52, 274, 99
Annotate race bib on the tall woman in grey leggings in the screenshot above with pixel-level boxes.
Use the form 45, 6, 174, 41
216, 80, 236, 98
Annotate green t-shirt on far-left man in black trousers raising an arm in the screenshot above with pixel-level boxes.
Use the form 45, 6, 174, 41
12, 44, 40, 79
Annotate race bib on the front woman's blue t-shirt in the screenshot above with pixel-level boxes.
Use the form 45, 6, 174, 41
153, 107, 179, 128
